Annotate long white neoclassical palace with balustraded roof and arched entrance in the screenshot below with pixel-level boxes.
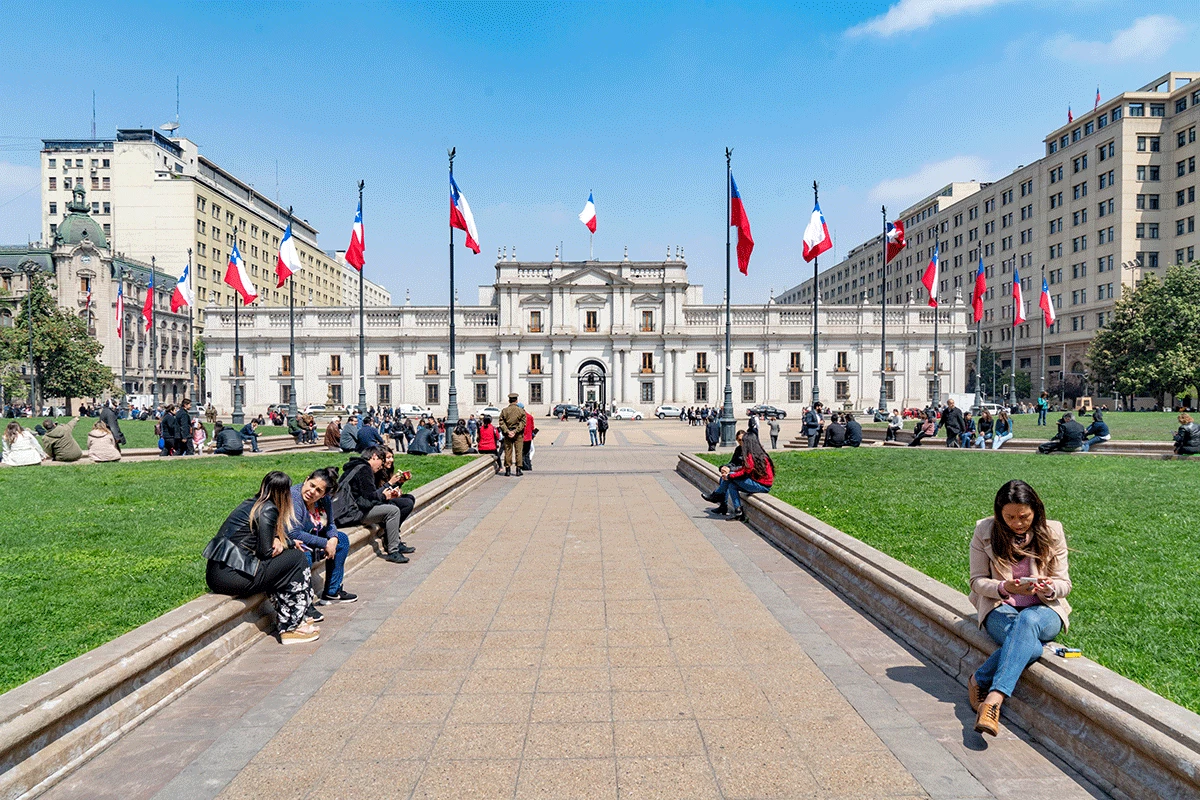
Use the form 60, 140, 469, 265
204, 257, 968, 416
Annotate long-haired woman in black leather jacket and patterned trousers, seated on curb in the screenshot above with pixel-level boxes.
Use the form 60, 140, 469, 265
204, 470, 320, 644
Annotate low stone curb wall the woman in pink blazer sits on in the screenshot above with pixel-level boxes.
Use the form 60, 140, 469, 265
677, 453, 1200, 800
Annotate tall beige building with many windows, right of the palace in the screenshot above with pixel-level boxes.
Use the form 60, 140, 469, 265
778, 72, 1200, 393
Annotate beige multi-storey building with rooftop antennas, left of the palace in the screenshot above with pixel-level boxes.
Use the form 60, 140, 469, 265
42, 128, 350, 330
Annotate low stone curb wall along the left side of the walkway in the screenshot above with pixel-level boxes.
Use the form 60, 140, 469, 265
0, 458, 493, 800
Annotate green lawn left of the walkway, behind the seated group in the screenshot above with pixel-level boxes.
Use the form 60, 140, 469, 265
0, 453, 469, 692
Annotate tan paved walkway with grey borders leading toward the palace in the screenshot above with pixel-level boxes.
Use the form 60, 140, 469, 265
46, 421, 1103, 800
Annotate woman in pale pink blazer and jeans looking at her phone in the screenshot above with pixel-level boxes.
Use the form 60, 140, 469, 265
967, 481, 1072, 736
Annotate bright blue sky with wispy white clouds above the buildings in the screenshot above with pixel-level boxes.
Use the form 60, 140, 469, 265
0, 0, 1200, 303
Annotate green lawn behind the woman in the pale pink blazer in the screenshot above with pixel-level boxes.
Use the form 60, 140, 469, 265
703, 448, 1200, 711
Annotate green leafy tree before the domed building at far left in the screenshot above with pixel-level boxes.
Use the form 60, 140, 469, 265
0, 272, 113, 408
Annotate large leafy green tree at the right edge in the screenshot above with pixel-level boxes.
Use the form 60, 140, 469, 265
1087, 263, 1200, 399
